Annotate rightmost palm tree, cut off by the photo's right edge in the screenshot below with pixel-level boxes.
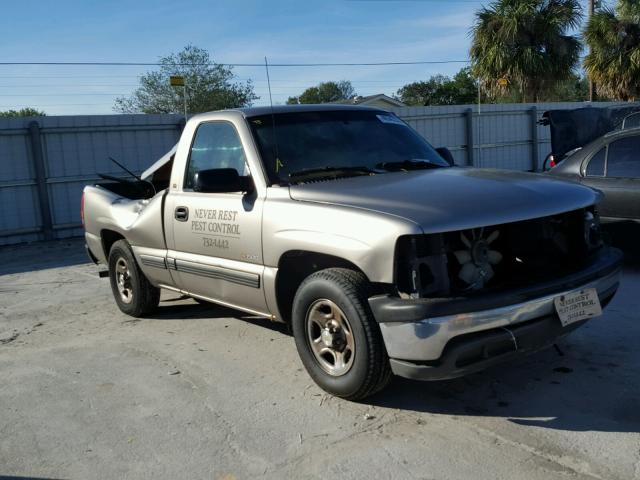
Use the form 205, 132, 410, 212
584, 0, 640, 101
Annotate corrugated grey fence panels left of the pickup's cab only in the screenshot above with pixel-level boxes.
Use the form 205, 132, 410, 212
0, 115, 182, 245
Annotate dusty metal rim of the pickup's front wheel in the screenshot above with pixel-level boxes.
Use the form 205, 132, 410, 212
306, 299, 356, 377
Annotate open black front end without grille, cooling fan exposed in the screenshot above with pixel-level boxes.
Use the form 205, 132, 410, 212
395, 207, 602, 299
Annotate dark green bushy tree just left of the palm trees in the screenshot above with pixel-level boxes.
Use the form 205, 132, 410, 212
395, 68, 478, 105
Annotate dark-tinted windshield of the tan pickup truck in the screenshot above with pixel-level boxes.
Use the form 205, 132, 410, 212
248, 110, 449, 184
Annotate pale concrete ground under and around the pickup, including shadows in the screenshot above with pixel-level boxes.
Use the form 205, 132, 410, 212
0, 227, 640, 480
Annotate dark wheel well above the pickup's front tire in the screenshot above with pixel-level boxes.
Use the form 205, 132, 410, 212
276, 250, 366, 323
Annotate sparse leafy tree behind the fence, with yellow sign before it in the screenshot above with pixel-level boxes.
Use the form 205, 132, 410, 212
114, 45, 258, 113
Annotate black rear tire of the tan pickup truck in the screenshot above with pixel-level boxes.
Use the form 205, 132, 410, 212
109, 240, 160, 317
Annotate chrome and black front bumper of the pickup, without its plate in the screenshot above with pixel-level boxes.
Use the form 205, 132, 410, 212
369, 248, 622, 380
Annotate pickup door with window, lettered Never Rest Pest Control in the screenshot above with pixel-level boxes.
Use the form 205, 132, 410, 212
166, 121, 268, 314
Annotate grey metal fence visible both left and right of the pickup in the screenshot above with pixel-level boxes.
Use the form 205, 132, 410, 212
0, 103, 624, 245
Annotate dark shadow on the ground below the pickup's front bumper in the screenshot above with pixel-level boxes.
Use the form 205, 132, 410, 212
365, 340, 640, 432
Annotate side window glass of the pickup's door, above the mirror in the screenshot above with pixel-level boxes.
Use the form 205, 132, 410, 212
184, 122, 248, 188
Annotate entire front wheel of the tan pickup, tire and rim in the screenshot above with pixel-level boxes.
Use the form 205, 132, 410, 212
292, 268, 391, 400
